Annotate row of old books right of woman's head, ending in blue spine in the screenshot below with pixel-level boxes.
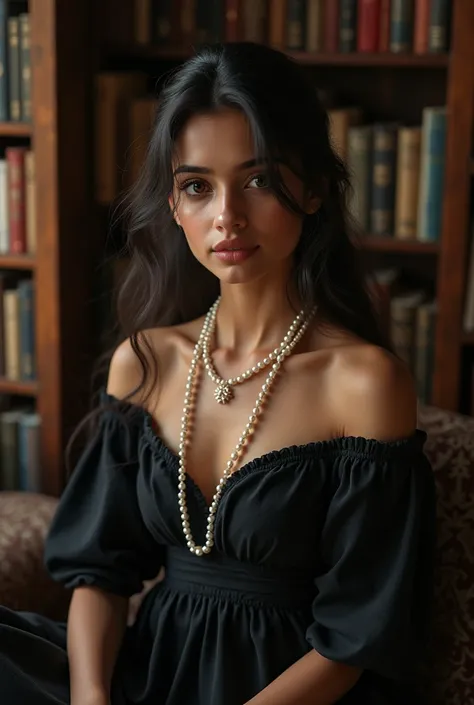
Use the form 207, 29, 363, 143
329, 106, 446, 242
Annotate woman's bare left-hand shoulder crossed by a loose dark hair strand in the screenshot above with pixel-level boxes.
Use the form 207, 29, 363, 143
107, 319, 202, 404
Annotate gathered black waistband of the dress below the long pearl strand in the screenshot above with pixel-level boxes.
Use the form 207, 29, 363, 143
164, 547, 316, 607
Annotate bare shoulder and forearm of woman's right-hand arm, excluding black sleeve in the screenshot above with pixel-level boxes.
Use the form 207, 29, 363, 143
245, 346, 417, 705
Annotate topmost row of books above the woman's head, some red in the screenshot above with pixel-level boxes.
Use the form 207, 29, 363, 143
134, 0, 451, 54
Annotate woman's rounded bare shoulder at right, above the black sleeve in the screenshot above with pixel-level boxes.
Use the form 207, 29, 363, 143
329, 341, 417, 440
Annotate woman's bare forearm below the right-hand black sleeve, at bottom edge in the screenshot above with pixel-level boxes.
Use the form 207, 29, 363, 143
245, 651, 361, 705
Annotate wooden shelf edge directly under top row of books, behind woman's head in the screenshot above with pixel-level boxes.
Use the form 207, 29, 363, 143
106, 44, 449, 68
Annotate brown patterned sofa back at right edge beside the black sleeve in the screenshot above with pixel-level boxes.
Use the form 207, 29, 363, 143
419, 407, 474, 705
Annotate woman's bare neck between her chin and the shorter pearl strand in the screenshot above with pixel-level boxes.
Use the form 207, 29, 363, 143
215, 282, 301, 355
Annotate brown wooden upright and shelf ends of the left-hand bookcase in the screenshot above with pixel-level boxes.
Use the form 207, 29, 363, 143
0, 0, 102, 495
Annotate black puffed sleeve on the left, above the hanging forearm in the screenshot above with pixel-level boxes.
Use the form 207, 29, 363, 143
45, 402, 163, 597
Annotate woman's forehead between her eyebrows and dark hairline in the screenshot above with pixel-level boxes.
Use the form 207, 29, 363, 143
176, 109, 254, 168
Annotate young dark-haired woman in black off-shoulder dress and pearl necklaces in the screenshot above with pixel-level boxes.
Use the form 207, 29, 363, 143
0, 44, 435, 705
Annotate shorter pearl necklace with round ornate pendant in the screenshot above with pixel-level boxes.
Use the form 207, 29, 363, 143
202, 297, 304, 404
